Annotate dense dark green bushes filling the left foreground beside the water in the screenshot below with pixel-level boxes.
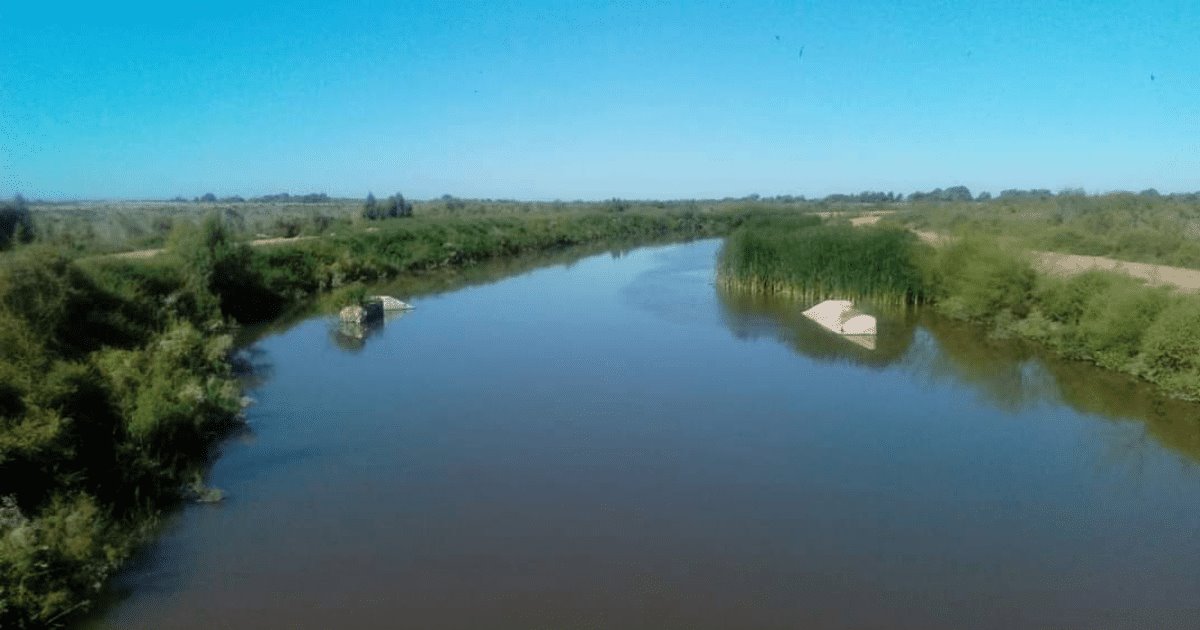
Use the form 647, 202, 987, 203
0, 242, 240, 628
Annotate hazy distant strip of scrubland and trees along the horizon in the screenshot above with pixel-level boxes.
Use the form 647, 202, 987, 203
7, 186, 1200, 256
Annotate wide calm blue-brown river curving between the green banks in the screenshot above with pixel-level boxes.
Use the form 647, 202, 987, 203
85, 241, 1200, 629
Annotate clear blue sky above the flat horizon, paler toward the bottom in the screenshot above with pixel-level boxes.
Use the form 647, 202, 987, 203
0, 0, 1200, 199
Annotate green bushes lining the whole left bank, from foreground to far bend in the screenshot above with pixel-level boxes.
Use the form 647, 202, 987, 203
0, 205, 743, 628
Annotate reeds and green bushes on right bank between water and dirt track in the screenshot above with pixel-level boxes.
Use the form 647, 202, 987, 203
719, 211, 1200, 400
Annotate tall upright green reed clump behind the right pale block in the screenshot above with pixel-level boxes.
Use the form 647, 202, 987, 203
719, 216, 925, 305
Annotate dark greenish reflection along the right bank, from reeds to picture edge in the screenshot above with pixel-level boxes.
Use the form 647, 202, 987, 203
716, 288, 1200, 461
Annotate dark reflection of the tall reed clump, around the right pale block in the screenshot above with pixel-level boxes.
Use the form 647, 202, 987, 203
716, 287, 916, 368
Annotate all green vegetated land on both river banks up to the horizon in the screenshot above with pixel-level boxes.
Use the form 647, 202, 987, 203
9, 187, 1200, 628
